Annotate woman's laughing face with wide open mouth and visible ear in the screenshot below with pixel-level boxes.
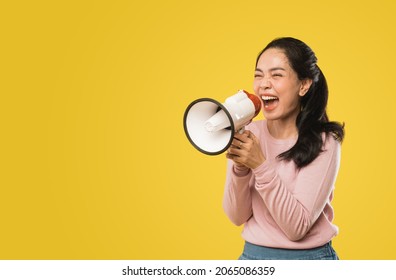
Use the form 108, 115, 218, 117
253, 48, 311, 121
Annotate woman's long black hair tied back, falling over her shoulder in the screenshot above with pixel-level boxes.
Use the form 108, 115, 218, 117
256, 37, 345, 168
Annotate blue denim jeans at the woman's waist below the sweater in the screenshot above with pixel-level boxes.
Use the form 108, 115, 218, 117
239, 241, 338, 260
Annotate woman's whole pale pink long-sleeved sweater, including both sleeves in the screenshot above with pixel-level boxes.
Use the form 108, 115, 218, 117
223, 120, 341, 249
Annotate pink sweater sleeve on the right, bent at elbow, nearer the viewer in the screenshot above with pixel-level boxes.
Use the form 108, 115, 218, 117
252, 136, 340, 241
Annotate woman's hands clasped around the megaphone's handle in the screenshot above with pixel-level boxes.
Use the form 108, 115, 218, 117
226, 130, 265, 169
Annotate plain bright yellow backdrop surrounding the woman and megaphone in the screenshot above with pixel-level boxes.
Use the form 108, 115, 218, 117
0, 0, 396, 259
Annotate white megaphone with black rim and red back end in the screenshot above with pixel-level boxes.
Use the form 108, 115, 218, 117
183, 90, 261, 155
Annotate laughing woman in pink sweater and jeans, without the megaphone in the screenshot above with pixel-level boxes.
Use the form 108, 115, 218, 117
223, 38, 344, 259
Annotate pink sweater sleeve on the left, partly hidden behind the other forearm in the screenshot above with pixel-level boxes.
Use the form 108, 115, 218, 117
223, 160, 252, 226
